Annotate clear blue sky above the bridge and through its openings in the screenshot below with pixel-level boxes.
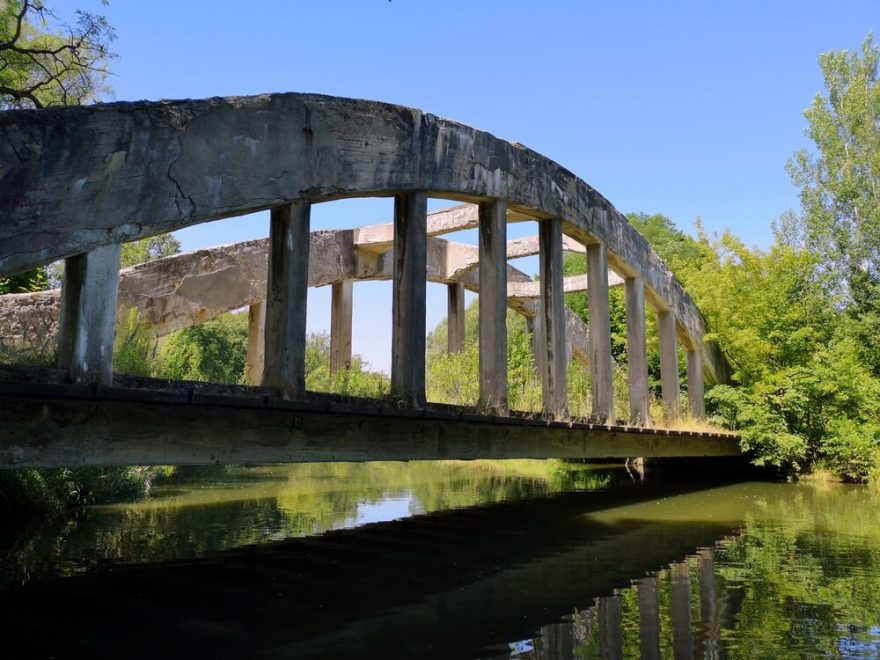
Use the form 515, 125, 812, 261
55, 0, 880, 369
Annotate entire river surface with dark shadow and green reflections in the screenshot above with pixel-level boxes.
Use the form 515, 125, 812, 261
0, 461, 880, 658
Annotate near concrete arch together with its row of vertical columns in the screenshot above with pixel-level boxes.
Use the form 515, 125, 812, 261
0, 94, 726, 423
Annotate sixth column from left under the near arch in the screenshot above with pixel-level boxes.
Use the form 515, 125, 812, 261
587, 243, 616, 424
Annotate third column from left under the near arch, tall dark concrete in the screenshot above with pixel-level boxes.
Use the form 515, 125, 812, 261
391, 192, 428, 408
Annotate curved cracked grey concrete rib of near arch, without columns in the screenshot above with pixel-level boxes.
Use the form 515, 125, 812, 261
0, 94, 725, 381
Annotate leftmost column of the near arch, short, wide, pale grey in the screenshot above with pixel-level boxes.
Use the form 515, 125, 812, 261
58, 244, 121, 385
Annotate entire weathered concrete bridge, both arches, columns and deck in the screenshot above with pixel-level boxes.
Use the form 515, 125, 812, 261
0, 94, 739, 467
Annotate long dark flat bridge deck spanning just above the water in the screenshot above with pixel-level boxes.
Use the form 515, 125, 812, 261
0, 369, 741, 468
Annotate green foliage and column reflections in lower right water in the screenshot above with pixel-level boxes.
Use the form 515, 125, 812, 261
516, 486, 880, 658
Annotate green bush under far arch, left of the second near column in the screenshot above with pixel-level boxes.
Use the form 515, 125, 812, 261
157, 314, 248, 384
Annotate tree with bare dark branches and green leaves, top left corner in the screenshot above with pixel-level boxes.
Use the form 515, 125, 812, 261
0, 0, 115, 109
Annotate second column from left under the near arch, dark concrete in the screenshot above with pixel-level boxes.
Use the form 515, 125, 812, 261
263, 201, 311, 399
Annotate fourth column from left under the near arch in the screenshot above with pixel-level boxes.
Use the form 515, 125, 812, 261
479, 201, 508, 415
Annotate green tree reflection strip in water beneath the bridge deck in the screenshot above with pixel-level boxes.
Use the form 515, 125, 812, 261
0, 460, 610, 583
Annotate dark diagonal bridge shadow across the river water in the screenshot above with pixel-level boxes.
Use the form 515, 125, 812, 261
0, 464, 756, 658
